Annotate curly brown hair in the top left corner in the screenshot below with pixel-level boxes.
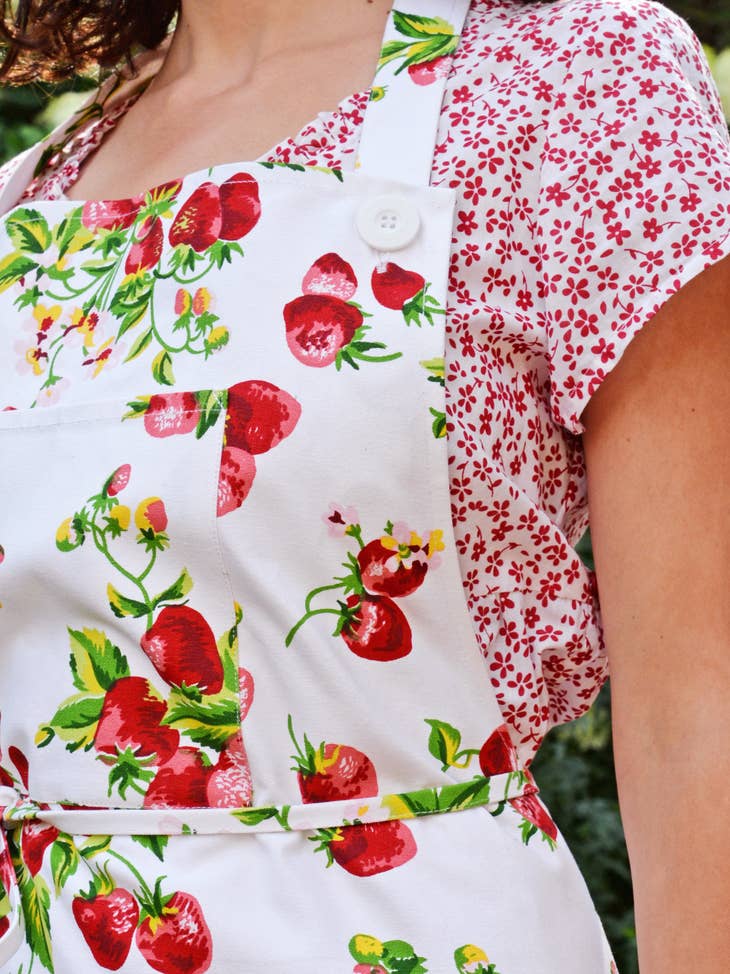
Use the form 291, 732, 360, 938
0, 0, 180, 84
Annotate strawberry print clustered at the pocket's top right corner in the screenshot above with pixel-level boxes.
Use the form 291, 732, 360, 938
122, 379, 302, 517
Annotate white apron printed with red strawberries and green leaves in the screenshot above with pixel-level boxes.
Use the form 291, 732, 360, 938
0, 0, 614, 974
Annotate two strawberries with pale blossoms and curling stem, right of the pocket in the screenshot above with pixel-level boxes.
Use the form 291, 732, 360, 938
285, 504, 444, 662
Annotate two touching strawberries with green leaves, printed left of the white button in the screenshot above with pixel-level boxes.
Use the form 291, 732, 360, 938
284, 253, 401, 371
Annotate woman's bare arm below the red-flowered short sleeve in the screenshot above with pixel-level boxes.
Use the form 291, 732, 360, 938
582, 258, 730, 974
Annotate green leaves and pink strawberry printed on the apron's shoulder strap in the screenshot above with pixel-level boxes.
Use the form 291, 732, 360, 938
378, 10, 459, 85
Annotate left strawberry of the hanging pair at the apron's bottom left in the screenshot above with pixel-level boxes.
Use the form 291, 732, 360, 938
71, 886, 139, 971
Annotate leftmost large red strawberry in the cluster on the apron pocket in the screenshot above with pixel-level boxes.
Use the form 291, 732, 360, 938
94, 676, 180, 764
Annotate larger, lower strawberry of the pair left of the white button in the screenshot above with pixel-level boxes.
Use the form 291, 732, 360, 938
284, 294, 363, 369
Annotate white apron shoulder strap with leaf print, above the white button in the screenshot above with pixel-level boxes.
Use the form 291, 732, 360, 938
355, 0, 470, 186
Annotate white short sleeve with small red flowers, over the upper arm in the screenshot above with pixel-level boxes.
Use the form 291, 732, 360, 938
537, 0, 730, 433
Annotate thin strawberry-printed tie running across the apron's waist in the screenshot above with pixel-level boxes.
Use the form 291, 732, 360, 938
2, 771, 539, 835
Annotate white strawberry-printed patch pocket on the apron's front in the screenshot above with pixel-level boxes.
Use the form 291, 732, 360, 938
0, 390, 253, 808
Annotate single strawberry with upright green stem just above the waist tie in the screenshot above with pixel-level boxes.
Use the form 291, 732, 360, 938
289, 717, 378, 805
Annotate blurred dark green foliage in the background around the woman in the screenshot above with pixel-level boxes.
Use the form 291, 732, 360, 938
0, 0, 730, 974
